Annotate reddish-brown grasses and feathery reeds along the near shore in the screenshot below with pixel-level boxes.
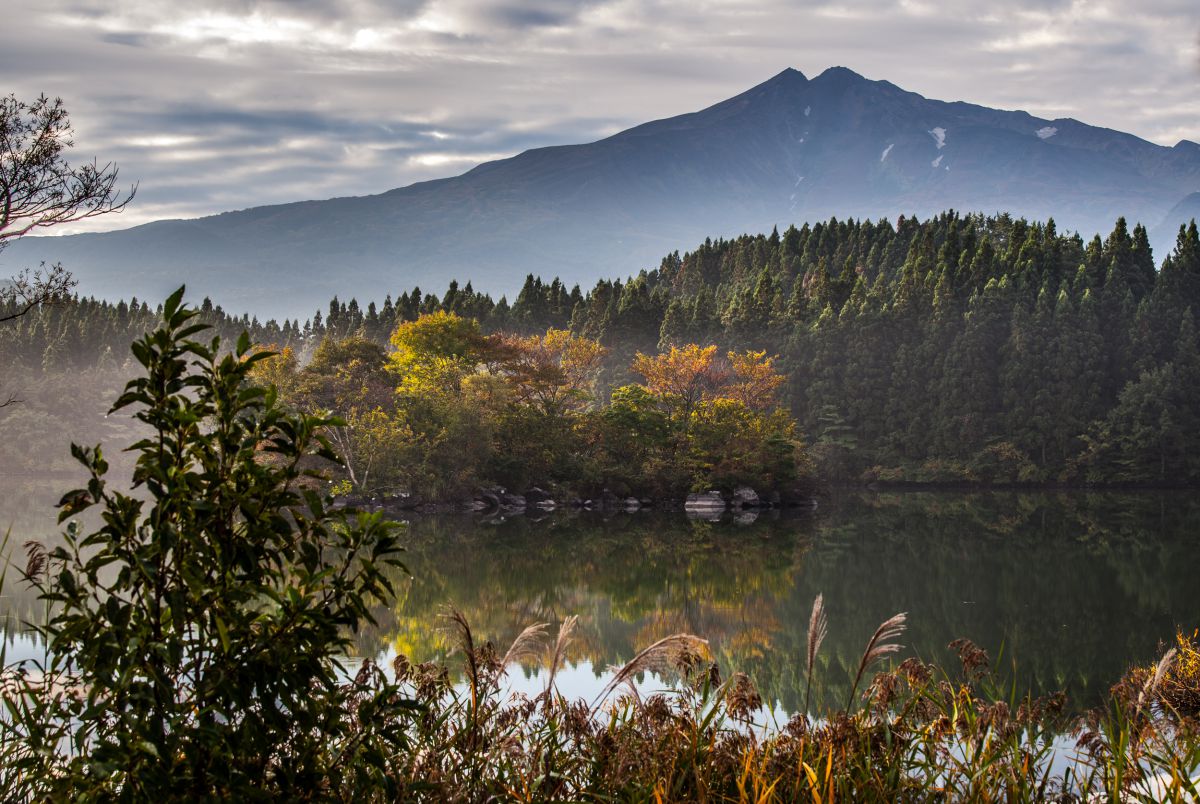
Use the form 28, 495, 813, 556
321, 598, 1200, 803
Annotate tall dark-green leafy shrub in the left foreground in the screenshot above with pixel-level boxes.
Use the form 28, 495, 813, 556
0, 289, 404, 800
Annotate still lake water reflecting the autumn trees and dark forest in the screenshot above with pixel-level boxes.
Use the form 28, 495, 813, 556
0, 484, 1200, 712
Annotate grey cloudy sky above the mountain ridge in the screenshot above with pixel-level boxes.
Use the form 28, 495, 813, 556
9, 0, 1200, 233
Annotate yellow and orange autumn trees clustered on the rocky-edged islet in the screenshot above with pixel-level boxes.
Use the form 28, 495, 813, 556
253, 311, 808, 500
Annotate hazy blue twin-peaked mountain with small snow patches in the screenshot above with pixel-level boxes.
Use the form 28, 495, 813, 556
9, 67, 1200, 316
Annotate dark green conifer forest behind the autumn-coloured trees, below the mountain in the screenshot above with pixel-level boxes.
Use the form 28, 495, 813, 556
7, 212, 1200, 485
